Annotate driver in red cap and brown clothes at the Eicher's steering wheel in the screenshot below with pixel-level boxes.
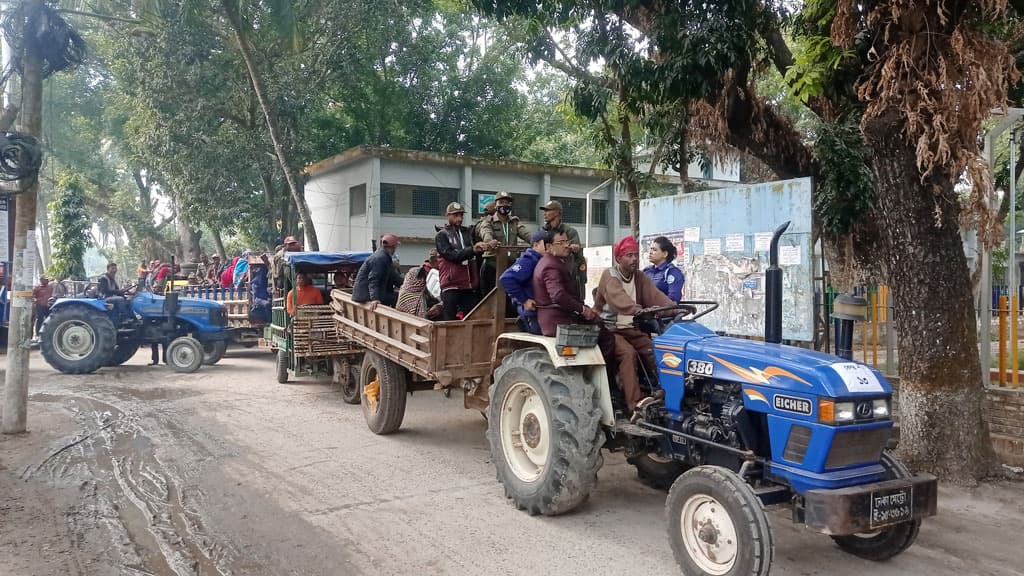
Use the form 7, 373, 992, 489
594, 236, 674, 412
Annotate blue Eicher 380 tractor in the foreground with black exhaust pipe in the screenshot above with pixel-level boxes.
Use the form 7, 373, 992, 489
487, 225, 937, 576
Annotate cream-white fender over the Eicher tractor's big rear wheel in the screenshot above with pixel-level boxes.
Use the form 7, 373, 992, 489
490, 332, 615, 426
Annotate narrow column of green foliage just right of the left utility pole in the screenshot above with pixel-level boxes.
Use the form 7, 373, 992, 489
47, 172, 91, 280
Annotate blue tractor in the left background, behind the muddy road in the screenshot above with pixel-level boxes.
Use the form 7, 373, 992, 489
40, 284, 230, 374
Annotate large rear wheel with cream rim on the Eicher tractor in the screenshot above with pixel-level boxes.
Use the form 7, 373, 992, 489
487, 348, 604, 516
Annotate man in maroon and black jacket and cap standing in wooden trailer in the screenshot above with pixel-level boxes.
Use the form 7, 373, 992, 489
434, 202, 498, 320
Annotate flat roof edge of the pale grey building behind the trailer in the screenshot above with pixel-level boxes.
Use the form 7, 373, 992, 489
303, 146, 647, 179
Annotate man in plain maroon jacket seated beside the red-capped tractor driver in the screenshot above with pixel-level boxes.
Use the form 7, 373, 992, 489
534, 232, 600, 336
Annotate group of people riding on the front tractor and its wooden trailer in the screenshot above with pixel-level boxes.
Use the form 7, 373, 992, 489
352, 192, 685, 412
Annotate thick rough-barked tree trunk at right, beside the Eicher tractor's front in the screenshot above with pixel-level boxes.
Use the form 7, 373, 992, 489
864, 117, 994, 484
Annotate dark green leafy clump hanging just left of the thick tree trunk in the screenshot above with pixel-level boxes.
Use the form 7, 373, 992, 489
814, 118, 874, 236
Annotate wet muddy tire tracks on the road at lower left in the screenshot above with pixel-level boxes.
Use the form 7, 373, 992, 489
22, 395, 238, 576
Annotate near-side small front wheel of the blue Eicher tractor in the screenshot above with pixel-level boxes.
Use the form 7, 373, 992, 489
665, 466, 774, 576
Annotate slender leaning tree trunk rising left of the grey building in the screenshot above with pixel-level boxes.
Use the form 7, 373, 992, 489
221, 0, 319, 251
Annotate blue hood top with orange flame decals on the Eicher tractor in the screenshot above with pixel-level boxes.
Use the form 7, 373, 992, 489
685, 336, 892, 398
